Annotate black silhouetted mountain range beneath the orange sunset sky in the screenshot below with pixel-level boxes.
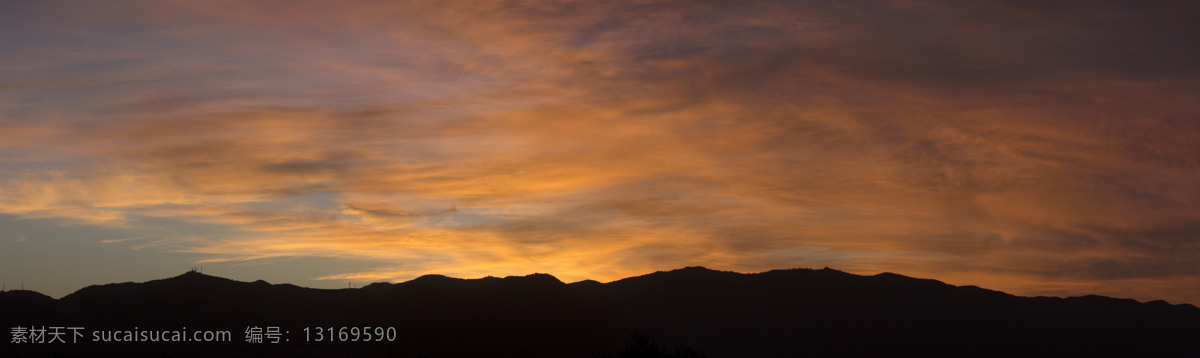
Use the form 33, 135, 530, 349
0, 268, 1200, 357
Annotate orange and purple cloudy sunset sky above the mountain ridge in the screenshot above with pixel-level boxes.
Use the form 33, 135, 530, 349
0, 0, 1200, 304
